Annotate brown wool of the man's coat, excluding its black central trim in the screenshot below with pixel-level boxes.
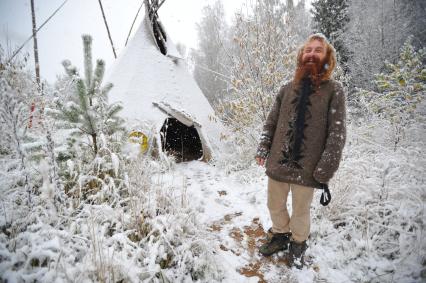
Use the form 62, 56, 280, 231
257, 80, 346, 187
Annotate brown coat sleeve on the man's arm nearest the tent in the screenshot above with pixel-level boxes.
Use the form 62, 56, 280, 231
256, 87, 284, 159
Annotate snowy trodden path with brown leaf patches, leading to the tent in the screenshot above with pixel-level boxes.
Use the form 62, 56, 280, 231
166, 162, 314, 282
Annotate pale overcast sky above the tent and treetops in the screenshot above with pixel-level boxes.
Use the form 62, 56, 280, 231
0, 0, 310, 82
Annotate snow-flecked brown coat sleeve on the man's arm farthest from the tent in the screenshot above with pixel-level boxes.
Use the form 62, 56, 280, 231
313, 84, 346, 184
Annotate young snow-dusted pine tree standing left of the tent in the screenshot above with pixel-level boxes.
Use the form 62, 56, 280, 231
52, 35, 125, 202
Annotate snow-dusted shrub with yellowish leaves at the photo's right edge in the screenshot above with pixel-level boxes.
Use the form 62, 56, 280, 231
358, 39, 426, 152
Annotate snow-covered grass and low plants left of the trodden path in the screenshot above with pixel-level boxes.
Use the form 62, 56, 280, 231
0, 152, 222, 282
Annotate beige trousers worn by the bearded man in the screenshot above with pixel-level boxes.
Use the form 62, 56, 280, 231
268, 178, 314, 242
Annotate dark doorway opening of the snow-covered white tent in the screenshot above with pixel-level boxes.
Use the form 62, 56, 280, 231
160, 118, 203, 162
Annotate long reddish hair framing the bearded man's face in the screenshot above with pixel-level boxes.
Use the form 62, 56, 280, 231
297, 33, 336, 81
